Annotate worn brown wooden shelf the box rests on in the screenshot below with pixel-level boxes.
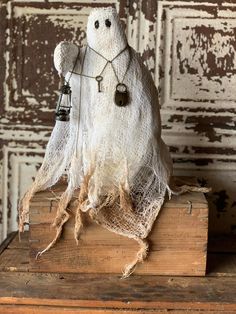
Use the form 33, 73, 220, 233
0, 232, 236, 314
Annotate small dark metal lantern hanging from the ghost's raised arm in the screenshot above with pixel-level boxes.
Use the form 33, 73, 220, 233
56, 82, 71, 121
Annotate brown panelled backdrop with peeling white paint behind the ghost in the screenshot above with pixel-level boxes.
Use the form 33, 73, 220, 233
0, 0, 236, 240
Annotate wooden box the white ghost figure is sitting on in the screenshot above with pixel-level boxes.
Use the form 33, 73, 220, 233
29, 178, 208, 276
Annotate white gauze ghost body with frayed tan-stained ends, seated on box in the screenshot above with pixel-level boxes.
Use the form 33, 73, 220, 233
19, 7, 209, 277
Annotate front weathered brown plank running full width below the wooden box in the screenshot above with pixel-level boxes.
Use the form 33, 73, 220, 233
0, 273, 236, 313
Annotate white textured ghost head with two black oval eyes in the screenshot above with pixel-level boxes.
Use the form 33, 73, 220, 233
87, 7, 127, 59
